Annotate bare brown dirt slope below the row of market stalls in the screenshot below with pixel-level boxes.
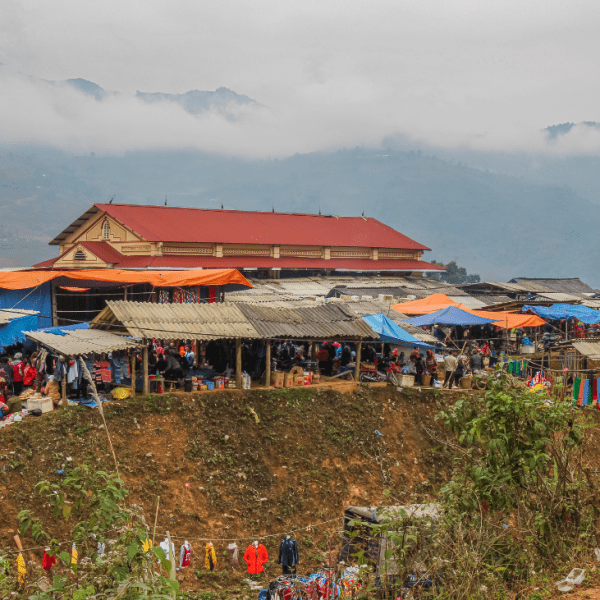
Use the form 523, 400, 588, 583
0, 386, 460, 598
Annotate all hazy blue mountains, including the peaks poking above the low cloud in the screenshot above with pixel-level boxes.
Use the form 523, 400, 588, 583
0, 70, 600, 287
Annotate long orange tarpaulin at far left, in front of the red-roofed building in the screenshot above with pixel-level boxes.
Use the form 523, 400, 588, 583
0, 269, 252, 290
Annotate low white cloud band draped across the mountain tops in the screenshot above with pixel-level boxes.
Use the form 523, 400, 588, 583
0, 67, 600, 158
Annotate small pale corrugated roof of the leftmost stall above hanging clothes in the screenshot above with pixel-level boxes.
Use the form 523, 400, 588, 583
25, 329, 139, 356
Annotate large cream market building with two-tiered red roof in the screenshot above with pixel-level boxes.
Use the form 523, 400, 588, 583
35, 204, 439, 279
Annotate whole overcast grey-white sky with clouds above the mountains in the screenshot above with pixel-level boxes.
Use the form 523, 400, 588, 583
0, 0, 600, 156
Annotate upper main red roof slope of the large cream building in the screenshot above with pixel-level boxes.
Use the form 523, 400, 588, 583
92, 204, 429, 250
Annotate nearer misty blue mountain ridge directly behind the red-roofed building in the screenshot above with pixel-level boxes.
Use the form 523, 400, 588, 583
0, 148, 600, 286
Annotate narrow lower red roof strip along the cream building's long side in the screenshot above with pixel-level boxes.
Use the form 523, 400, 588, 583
111, 256, 443, 271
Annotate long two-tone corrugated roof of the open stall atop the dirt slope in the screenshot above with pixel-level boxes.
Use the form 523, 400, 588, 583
91, 300, 373, 340
